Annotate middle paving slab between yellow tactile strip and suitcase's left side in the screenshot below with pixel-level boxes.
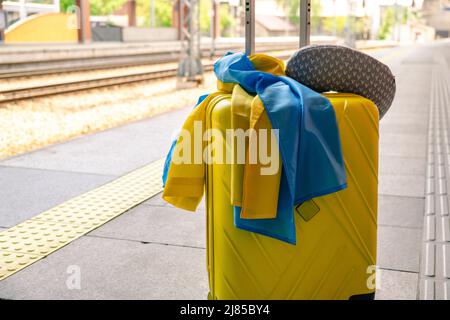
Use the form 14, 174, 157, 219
89, 205, 206, 248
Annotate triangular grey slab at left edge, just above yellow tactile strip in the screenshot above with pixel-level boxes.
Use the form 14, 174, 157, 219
0, 164, 115, 227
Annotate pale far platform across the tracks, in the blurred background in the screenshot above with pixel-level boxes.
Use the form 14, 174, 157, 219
0, 36, 396, 79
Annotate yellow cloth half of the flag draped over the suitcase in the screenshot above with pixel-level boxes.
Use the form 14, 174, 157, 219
163, 54, 285, 219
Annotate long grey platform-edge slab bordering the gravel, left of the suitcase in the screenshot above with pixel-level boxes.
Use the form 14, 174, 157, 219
2, 108, 190, 176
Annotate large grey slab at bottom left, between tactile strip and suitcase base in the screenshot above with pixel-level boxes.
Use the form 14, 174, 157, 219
0, 237, 208, 299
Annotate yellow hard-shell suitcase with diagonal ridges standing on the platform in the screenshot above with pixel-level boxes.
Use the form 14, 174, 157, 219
206, 93, 378, 299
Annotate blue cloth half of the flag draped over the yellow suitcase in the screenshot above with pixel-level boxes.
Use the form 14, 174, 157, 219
164, 53, 347, 244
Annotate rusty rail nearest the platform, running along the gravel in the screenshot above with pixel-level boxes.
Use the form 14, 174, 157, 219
0, 53, 290, 104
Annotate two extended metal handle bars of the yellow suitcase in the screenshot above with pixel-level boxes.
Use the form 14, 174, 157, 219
245, 0, 311, 56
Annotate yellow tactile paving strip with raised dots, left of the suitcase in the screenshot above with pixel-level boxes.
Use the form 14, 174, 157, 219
0, 159, 164, 281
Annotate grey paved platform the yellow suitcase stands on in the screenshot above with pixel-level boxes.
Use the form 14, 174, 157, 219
0, 42, 450, 299
